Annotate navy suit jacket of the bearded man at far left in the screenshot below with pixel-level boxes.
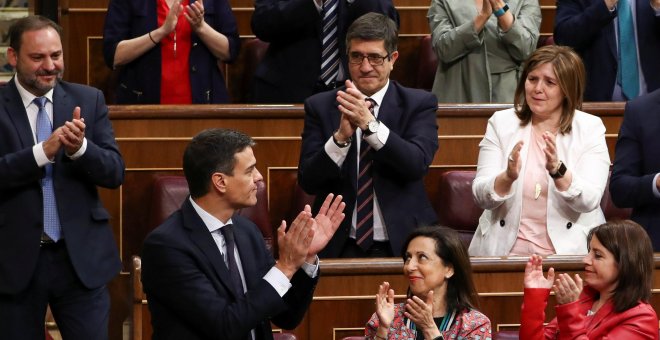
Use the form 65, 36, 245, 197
0, 78, 124, 294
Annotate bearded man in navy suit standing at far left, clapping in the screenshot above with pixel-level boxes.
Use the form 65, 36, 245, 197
0, 16, 124, 340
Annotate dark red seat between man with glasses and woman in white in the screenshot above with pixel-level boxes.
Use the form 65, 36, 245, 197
436, 170, 483, 246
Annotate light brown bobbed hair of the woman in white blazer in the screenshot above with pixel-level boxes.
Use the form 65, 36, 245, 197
513, 45, 586, 134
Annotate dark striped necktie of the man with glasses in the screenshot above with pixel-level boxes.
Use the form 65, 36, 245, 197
355, 98, 376, 251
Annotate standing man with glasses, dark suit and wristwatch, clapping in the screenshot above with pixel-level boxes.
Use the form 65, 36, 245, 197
298, 13, 438, 257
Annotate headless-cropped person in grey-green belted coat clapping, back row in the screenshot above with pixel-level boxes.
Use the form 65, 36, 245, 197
427, 0, 541, 103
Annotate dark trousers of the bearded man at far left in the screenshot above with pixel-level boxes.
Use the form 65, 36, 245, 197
0, 242, 110, 340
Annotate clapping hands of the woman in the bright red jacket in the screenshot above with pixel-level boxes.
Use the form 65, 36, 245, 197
523, 255, 584, 305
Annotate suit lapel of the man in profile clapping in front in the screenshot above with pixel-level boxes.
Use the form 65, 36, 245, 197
181, 198, 242, 296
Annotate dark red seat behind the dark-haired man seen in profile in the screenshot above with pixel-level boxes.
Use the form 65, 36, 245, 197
149, 176, 273, 249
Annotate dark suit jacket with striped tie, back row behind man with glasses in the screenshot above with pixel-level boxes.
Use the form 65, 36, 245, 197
250, 0, 399, 103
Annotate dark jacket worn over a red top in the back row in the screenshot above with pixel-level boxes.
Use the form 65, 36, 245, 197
103, 0, 240, 104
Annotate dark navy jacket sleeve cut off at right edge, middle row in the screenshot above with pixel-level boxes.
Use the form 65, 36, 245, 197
610, 90, 660, 251
